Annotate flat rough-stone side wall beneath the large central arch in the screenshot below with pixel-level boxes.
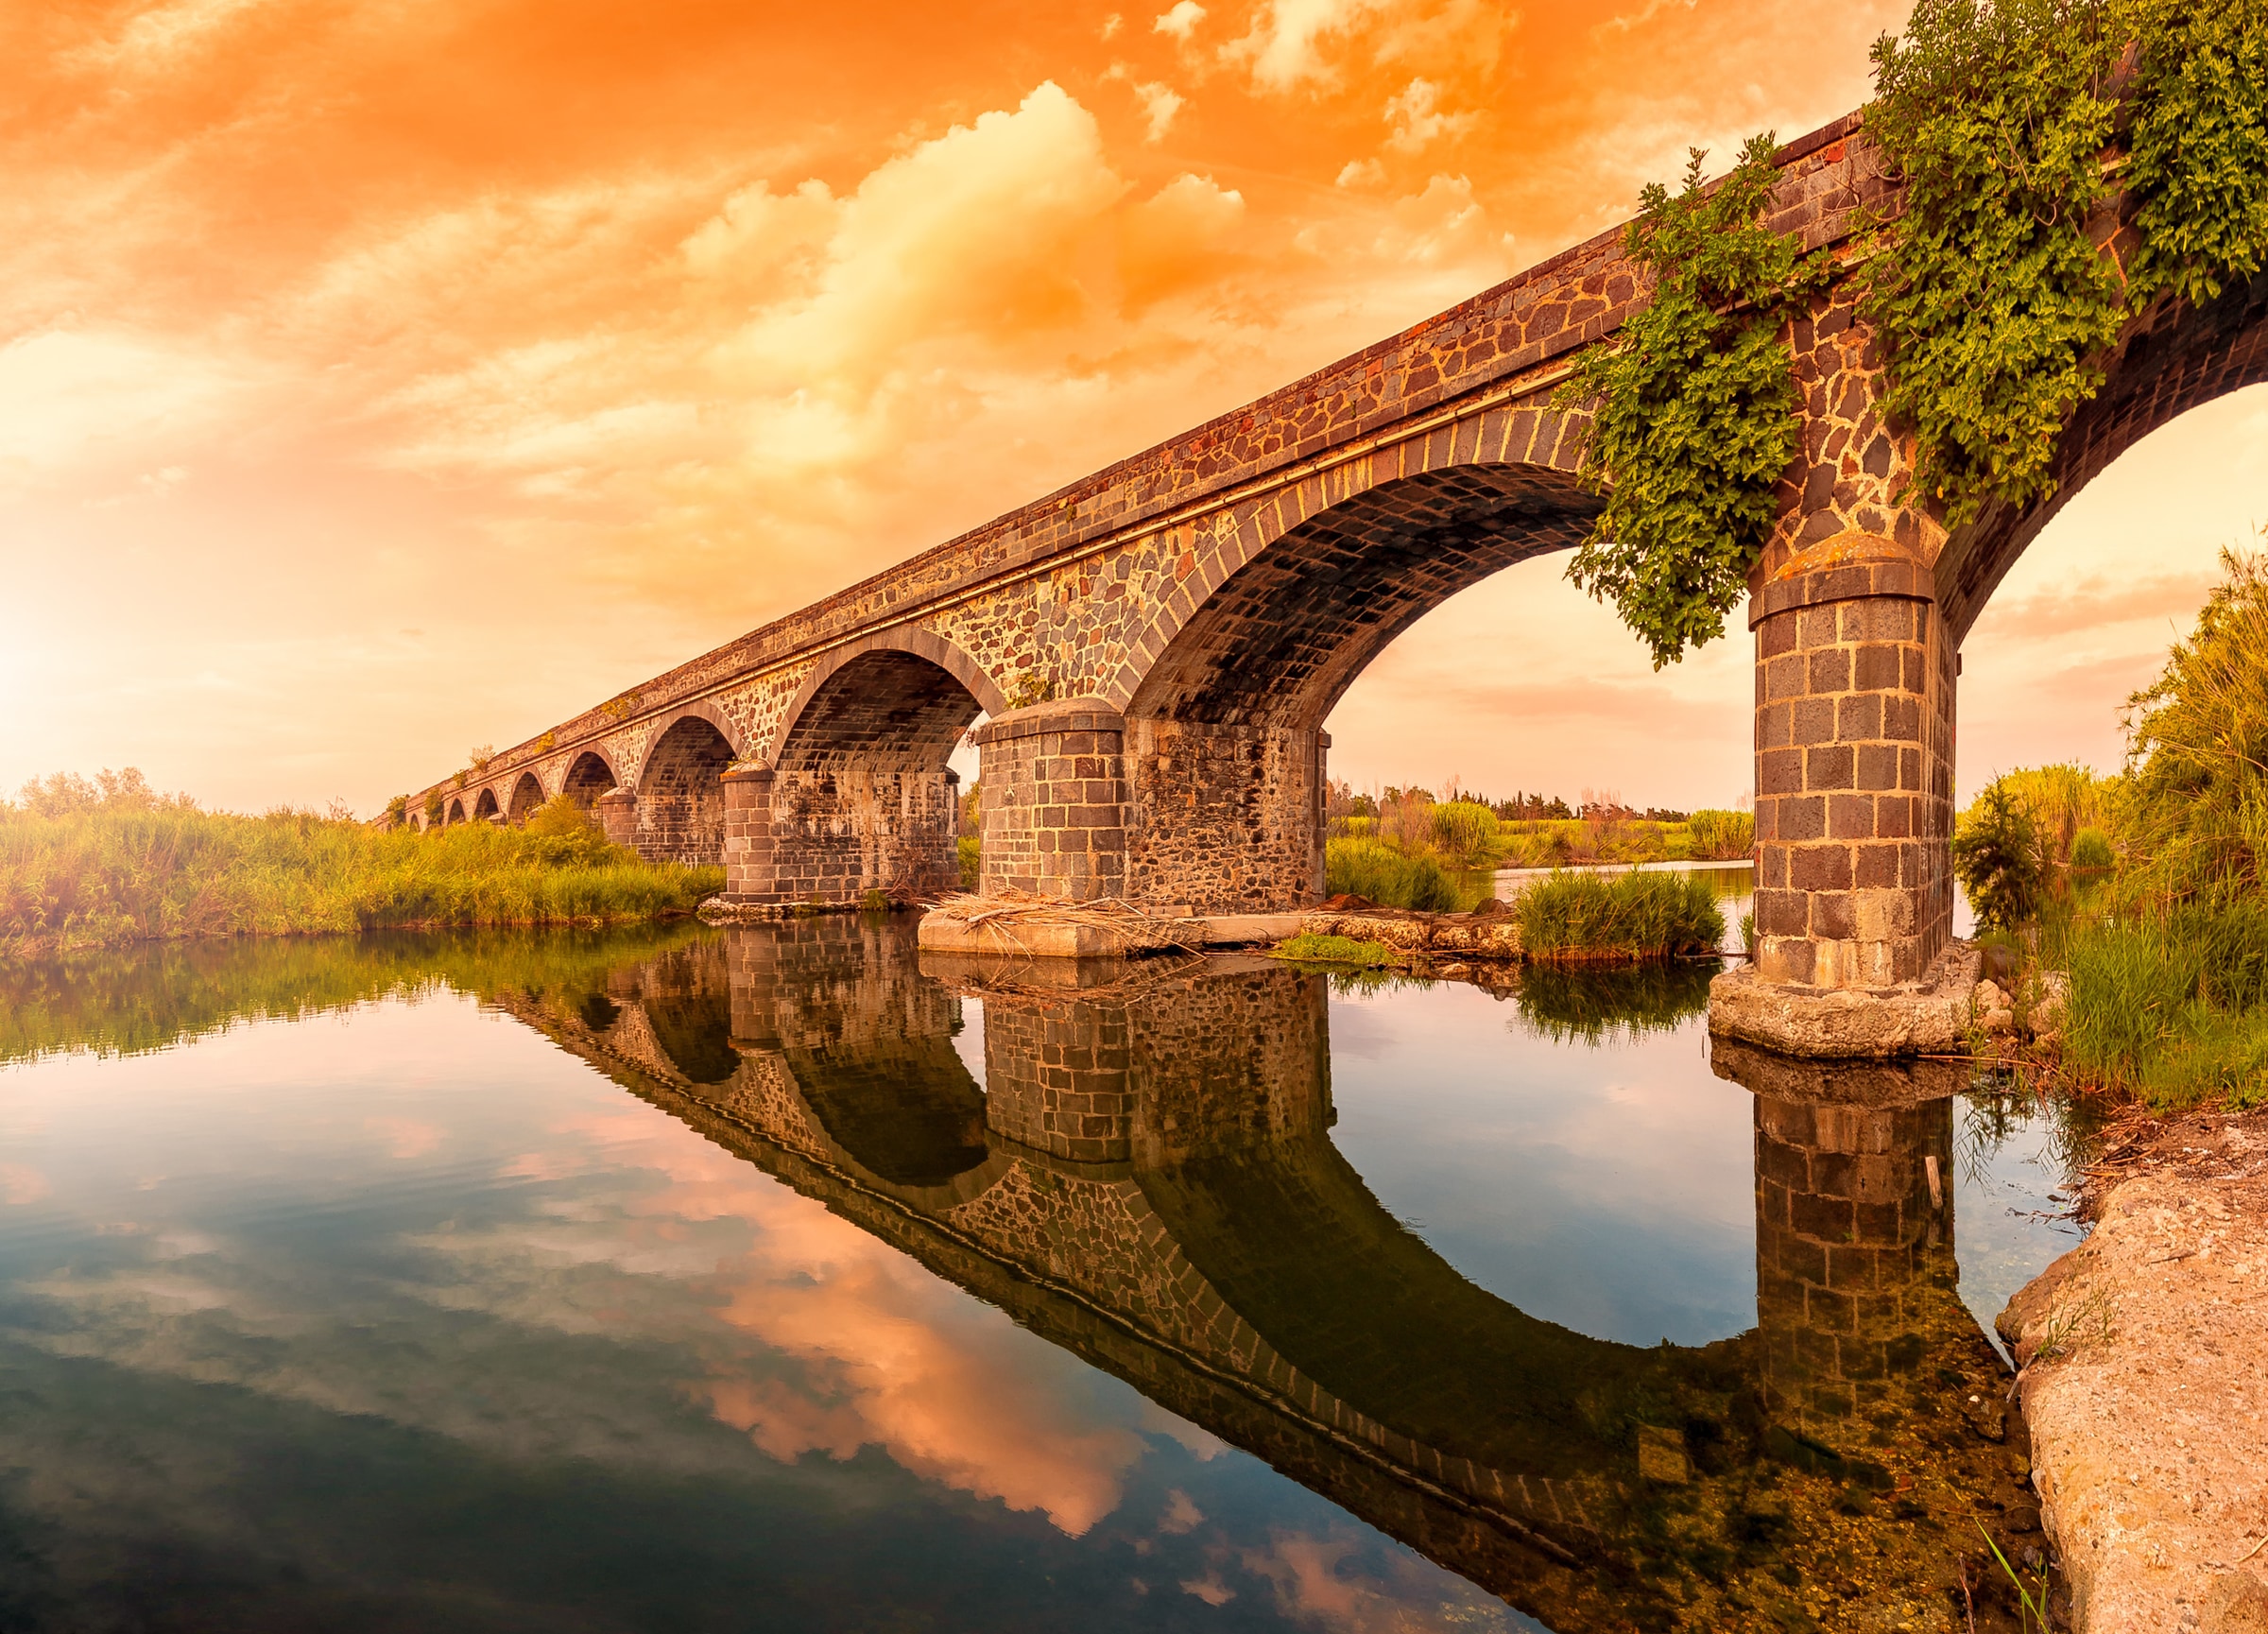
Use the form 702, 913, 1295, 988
1125, 719, 1332, 912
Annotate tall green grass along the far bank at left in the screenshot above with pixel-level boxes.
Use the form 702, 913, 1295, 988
0, 801, 724, 957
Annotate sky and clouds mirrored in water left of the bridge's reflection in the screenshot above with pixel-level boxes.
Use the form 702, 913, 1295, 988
0, 985, 1515, 1627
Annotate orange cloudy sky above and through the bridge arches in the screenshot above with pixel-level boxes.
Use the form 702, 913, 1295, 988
0, 0, 2268, 813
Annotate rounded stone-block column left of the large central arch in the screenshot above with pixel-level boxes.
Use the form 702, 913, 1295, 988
975, 699, 1127, 901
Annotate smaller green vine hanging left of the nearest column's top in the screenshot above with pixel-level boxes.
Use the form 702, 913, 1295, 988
1555, 134, 1830, 669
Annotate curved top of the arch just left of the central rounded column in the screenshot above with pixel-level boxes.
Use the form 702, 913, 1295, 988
771, 627, 1007, 771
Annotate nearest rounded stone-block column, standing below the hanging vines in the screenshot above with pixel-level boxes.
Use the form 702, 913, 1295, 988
1748, 533, 1960, 989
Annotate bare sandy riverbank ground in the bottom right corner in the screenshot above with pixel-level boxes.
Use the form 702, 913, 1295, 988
1998, 1112, 2268, 1634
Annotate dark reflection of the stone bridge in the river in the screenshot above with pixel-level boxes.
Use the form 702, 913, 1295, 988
494, 920, 2036, 1634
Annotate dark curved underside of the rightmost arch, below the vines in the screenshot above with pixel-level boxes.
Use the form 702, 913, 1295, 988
1937, 272, 2268, 646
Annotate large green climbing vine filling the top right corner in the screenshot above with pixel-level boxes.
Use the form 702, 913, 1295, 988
1866, 0, 2268, 525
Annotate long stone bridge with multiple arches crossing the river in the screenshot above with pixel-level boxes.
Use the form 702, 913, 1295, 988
410, 115, 2268, 988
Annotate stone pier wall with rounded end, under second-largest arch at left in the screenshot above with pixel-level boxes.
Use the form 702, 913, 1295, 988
724, 763, 959, 908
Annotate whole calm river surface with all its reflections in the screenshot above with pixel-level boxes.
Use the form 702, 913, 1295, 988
0, 920, 2070, 1634
